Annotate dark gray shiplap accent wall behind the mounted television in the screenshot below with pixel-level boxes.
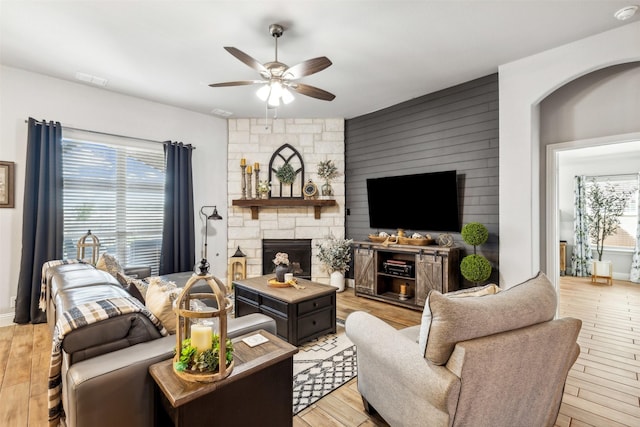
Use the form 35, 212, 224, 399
345, 74, 499, 285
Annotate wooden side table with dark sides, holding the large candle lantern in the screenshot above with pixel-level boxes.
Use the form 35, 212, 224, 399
149, 330, 298, 427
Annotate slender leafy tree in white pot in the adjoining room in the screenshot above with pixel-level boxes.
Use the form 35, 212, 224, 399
585, 179, 634, 277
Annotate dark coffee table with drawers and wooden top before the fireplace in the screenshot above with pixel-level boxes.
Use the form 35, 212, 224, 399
233, 274, 337, 346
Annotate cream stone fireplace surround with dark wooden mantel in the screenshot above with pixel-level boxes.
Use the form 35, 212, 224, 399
227, 119, 345, 283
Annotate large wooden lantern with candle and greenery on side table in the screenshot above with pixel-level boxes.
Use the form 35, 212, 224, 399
173, 259, 233, 383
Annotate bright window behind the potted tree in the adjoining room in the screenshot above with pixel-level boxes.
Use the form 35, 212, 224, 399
586, 175, 638, 249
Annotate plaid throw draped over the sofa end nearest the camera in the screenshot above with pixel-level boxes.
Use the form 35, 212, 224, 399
47, 297, 167, 427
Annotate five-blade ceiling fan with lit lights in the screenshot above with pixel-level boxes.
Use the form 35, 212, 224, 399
209, 24, 336, 108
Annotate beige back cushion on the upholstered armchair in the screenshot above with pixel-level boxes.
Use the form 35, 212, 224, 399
425, 272, 557, 365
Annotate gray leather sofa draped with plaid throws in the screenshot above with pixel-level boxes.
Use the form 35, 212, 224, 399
46, 264, 276, 427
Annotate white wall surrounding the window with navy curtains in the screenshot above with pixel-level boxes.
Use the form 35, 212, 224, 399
0, 67, 227, 323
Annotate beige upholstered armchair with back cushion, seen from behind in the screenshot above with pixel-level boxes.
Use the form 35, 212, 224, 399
346, 273, 582, 427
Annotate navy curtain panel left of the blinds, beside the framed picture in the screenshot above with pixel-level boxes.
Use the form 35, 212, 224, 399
13, 118, 63, 324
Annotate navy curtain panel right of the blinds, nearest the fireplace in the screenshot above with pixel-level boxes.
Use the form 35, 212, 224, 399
160, 141, 196, 275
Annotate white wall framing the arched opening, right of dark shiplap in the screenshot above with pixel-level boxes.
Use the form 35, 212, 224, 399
498, 22, 640, 287
